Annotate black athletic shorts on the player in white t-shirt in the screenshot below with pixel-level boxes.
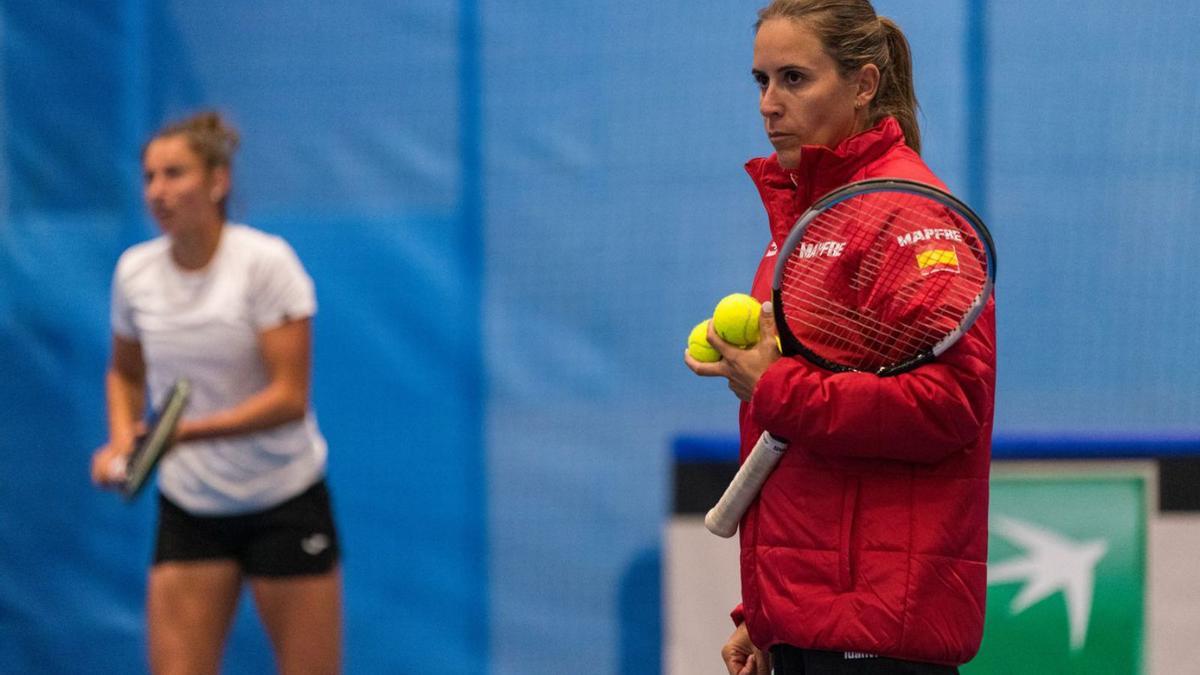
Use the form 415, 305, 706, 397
154, 480, 340, 577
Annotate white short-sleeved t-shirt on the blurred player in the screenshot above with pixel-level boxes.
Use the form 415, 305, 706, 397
112, 223, 326, 515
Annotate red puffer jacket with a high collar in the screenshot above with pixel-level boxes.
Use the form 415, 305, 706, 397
733, 118, 996, 664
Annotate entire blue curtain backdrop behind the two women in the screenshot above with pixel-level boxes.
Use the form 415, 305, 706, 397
0, 0, 1200, 674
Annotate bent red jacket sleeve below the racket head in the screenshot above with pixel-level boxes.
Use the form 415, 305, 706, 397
749, 300, 996, 464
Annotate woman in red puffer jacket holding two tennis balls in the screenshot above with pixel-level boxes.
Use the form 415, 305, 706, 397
685, 0, 995, 675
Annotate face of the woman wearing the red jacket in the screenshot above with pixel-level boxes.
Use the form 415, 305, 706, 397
754, 18, 878, 168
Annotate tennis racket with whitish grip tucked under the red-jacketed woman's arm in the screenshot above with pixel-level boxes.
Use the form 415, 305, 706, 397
704, 179, 996, 537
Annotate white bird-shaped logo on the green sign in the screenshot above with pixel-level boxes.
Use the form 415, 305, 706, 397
988, 515, 1109, 651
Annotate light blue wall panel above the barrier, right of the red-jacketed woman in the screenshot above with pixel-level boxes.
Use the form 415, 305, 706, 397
988, 1, 1200, 435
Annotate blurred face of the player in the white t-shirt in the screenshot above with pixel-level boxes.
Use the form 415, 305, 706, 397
142, 136, 228, 237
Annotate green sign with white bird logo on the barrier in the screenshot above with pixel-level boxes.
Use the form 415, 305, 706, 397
961, 465, 1152, 675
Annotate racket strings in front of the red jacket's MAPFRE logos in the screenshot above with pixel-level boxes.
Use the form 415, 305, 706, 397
780, 192, 988, 370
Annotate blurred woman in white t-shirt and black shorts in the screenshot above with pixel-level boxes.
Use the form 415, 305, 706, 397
92, 113, 342, 673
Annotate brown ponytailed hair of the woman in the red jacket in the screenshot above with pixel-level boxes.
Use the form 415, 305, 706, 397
755, 0, 920, 154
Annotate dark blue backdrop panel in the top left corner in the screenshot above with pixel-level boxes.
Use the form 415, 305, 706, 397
0, 1, 127, 215
